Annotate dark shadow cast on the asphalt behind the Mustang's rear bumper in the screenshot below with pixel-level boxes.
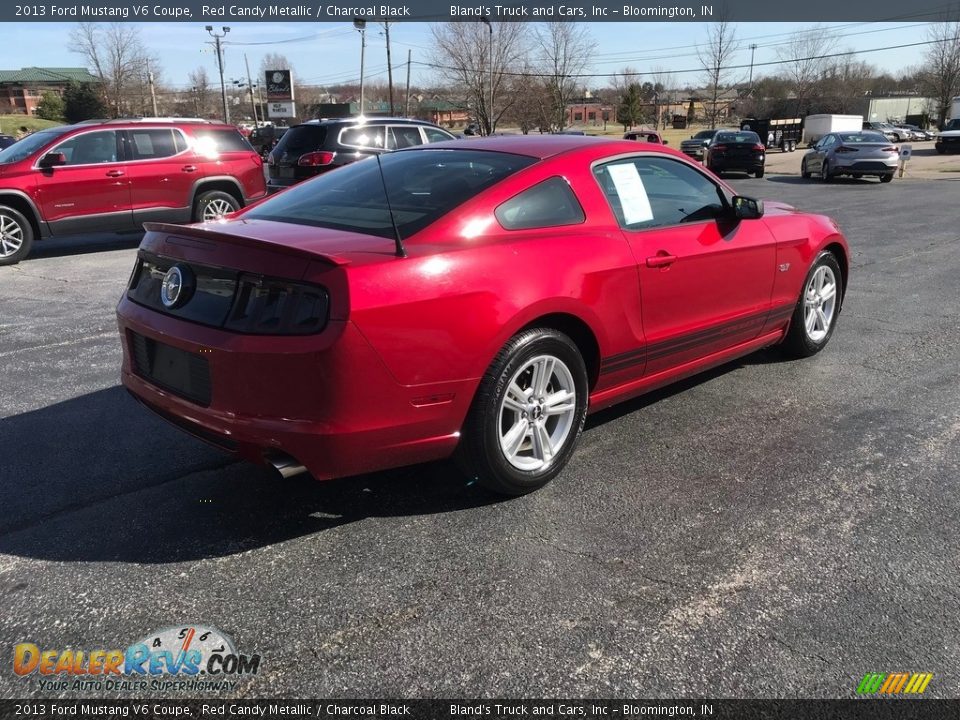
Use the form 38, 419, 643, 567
0, 387, 500, 563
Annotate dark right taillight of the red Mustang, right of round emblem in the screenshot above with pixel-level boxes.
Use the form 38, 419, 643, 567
224, 275, 330, 335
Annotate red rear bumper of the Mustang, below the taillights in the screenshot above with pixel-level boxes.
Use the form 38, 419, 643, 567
117, 297, 476, 479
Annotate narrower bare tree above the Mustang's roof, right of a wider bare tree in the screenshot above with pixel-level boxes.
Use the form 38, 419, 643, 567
535, 22, 596, 130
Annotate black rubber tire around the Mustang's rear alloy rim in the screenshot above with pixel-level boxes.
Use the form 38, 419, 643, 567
454, 328, 589, 496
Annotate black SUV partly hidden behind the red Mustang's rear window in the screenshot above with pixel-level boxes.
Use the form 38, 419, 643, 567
267, 118, 456, 192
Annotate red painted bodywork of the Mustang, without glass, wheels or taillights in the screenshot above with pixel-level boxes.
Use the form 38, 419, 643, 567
118, 136, 848, 478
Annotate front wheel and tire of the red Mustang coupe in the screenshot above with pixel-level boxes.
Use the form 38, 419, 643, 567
783, 251, 843, 357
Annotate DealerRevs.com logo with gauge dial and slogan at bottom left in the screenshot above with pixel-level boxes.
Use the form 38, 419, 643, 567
13, 625, 260, 691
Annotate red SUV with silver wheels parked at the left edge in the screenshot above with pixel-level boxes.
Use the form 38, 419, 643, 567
0, 118, 267, 265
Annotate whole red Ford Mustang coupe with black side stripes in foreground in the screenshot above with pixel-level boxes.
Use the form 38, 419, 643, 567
118, 135, 849, 495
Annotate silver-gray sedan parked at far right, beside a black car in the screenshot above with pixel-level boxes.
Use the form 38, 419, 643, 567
800, 130, 900, 182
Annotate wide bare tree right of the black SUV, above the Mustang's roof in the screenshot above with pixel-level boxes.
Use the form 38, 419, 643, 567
431, 22, 527, 134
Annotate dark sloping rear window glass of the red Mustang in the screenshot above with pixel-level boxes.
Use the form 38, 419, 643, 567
244, 149, 536, 238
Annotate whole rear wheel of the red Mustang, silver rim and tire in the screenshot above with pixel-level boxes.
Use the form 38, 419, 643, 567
456, 328, 589, 495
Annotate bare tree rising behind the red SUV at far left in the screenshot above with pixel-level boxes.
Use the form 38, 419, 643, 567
69, 23, 160, 116
